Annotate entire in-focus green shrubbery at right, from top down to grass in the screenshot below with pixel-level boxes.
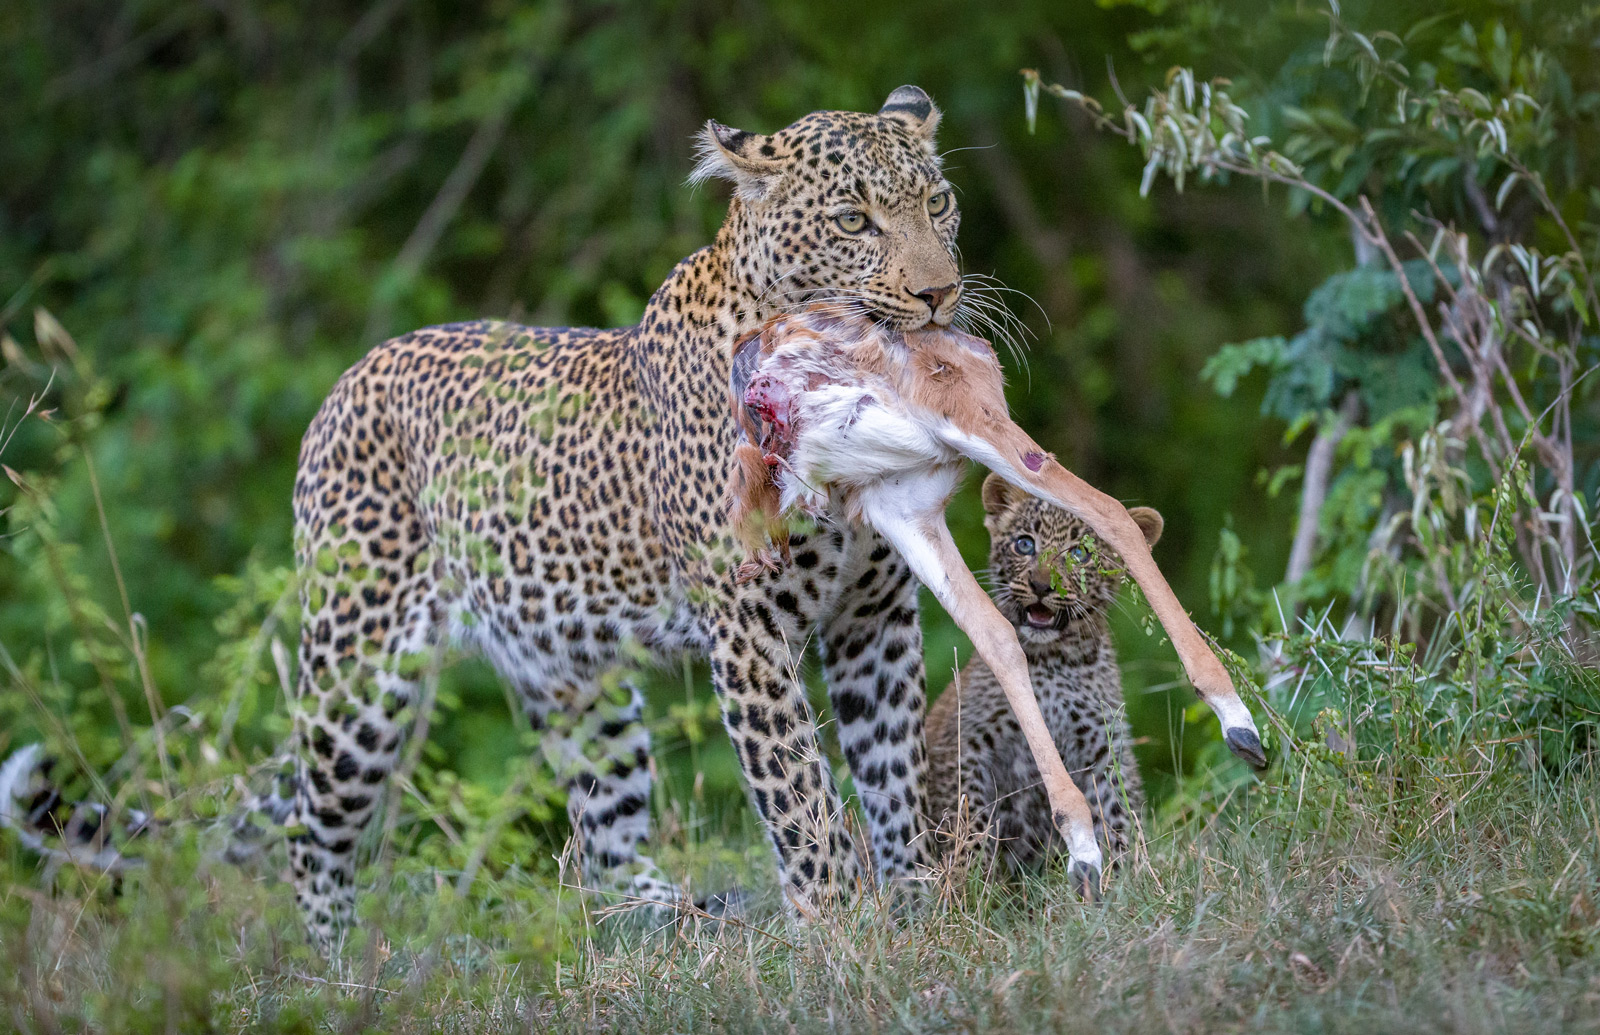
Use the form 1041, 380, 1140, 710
1024, 3, 1600, 840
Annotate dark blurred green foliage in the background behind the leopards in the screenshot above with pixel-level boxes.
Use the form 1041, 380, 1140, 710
0, 0, 1376, 825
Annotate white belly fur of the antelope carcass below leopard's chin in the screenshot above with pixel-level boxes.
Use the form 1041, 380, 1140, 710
779, 384, 966, 512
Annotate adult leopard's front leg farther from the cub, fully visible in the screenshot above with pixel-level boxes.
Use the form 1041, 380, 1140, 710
709, 588, 862, 917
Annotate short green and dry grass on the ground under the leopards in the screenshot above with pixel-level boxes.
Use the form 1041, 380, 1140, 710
9, 719, 1600, 1032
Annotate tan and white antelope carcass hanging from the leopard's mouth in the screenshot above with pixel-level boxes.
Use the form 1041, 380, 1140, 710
730, 310, 1267, 893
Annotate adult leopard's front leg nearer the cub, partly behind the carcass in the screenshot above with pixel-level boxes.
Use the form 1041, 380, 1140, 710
822, 533, 931, 888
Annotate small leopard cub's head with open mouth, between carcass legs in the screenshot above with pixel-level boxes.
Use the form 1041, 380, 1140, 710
984, 475, 1162, 643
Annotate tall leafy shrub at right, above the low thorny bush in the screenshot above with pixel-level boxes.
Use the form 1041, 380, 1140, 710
1024, 5, 1600, 636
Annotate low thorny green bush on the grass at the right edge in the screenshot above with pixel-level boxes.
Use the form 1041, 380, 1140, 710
1264, 467, 1600, 777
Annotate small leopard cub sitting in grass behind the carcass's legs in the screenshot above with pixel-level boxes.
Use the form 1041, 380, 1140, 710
926, 475, 1162, 872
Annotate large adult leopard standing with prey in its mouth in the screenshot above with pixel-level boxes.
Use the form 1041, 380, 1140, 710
290, 86, 962, 941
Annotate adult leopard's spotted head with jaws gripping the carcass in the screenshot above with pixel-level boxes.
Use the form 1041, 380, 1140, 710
690, 86, 962, 330
